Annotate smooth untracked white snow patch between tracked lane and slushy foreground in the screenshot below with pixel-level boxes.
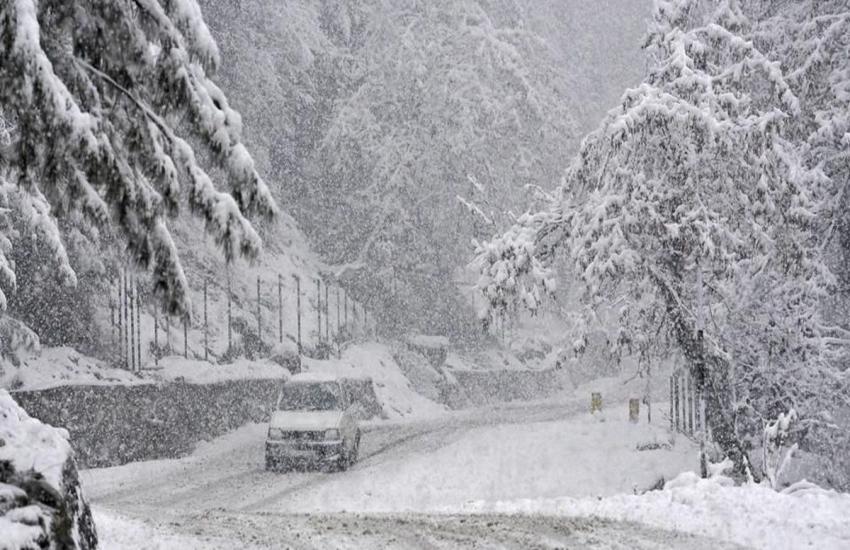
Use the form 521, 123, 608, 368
264, 405, 697, 512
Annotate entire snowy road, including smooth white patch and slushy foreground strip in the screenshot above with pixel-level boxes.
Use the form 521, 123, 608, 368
81, 402, 744, 548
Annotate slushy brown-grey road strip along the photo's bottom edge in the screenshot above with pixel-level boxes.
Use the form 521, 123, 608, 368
95, 512, 743, 550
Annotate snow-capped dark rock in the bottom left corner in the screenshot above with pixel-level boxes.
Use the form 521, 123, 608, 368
0, 390, 97, 550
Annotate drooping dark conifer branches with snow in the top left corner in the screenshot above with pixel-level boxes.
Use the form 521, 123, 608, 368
0, 0, 276, 320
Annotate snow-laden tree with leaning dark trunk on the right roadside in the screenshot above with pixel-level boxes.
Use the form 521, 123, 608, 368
478, 0, 835, 475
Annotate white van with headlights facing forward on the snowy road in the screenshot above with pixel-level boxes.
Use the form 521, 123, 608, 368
266, 373, 360, 470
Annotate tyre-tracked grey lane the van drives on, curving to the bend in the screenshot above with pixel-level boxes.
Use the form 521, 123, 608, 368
82, 403, 588, 516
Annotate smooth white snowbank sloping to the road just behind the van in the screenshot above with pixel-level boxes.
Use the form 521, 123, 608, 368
302, 342, 447, 419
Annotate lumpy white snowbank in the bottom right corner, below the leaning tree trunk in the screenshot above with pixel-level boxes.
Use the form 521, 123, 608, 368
458, 473, 850, 550
